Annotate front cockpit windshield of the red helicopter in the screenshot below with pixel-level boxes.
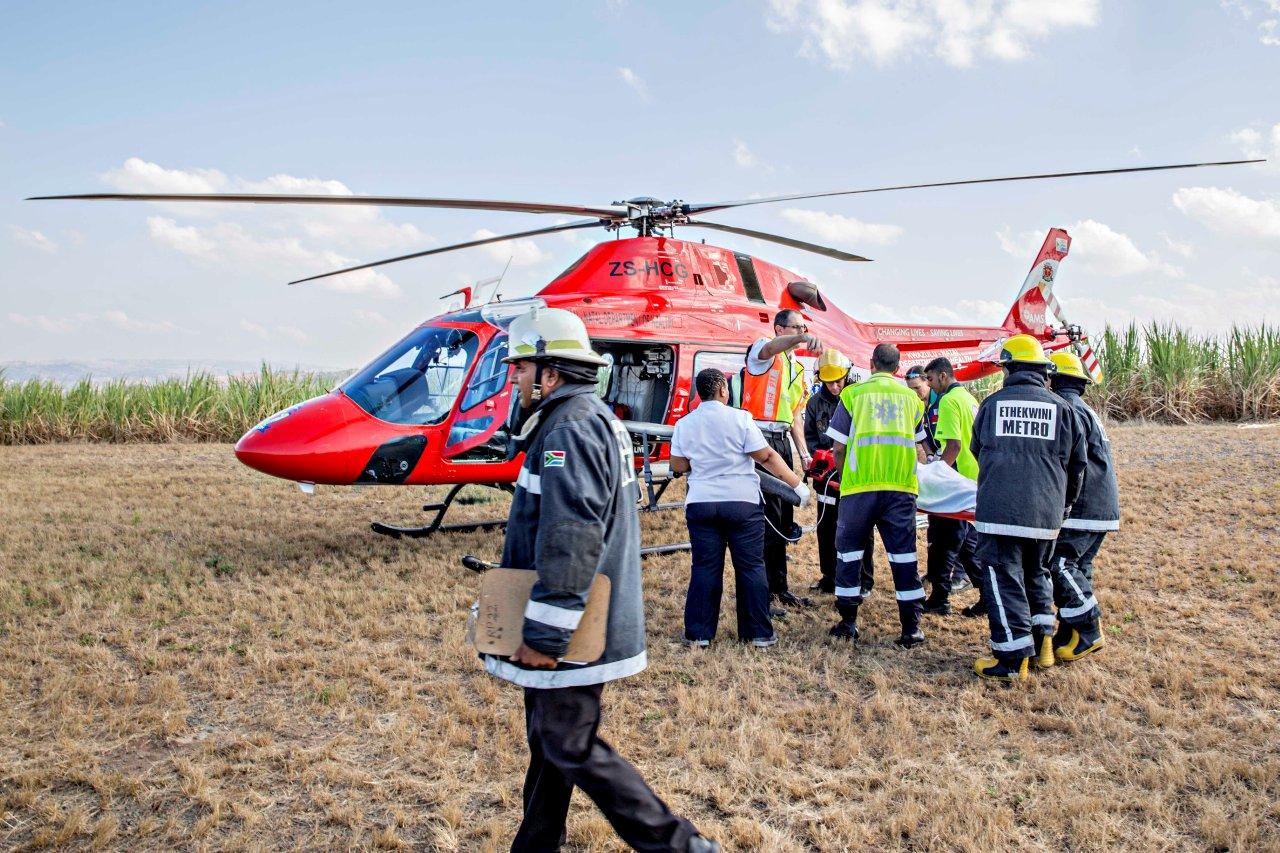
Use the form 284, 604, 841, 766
342, 327, 479, 425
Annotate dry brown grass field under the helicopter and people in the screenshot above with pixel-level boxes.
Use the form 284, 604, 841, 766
0, 425, 1280, 850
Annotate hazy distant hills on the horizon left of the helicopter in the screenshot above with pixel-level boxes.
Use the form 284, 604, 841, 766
0, 359, 351, 386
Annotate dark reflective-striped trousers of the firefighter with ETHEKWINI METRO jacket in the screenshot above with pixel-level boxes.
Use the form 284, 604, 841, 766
978, 530, 1055, 663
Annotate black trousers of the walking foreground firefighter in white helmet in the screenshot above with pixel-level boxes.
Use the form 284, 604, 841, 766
511, 684, 698, 853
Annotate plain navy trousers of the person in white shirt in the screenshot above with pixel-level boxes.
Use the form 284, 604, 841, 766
685, 501, 773, 640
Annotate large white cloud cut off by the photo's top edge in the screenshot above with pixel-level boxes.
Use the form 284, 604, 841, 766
768, 0, 1100, 70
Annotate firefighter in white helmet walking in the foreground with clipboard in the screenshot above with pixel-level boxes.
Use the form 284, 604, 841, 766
485, 307, 719, 850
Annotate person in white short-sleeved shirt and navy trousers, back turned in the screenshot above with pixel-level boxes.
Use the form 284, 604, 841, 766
671, 368, 809, 648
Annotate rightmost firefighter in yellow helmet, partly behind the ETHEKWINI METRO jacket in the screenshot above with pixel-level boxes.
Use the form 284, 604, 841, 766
1050, 352, 1120, 661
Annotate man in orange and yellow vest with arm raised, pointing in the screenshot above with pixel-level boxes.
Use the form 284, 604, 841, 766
741, 309, 823, 607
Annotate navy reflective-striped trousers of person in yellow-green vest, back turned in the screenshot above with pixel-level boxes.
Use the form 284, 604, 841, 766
836, 492, 924, 634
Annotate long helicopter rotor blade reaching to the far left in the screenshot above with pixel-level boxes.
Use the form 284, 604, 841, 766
27, 192, 627, 219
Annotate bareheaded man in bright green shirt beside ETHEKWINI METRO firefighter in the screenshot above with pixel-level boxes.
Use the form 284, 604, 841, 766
924, 357, 987, 617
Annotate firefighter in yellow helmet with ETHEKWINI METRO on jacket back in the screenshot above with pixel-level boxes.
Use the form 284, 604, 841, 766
970, 334, 1087, 680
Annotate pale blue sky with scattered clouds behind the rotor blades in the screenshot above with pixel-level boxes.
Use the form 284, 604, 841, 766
0, 0, 1280, 366
